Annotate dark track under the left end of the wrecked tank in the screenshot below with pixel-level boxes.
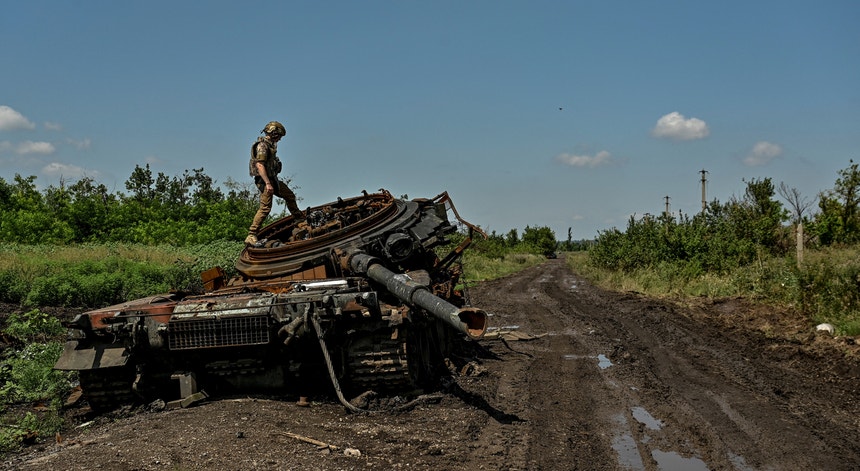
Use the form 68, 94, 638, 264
80, 365, 137, 412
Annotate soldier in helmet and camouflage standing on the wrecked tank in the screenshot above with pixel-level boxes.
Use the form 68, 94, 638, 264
245, 121, 304, 245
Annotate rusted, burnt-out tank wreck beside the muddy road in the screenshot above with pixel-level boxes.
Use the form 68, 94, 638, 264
55, 190, 487, 410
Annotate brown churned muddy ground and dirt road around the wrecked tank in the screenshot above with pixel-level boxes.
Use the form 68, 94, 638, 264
3, 259, 860, 470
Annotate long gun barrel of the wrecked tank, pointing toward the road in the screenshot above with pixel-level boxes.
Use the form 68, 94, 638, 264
349, 252, 487, 339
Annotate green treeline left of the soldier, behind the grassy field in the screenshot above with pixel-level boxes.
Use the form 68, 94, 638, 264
0, 165, 257, 246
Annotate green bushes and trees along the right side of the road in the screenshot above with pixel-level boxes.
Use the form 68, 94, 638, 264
589, 160, 860, 276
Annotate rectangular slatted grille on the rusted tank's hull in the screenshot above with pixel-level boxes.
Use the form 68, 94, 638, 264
168, 316, 270, 350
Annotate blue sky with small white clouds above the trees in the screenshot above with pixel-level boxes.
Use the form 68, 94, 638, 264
0, 0, 860, 240
